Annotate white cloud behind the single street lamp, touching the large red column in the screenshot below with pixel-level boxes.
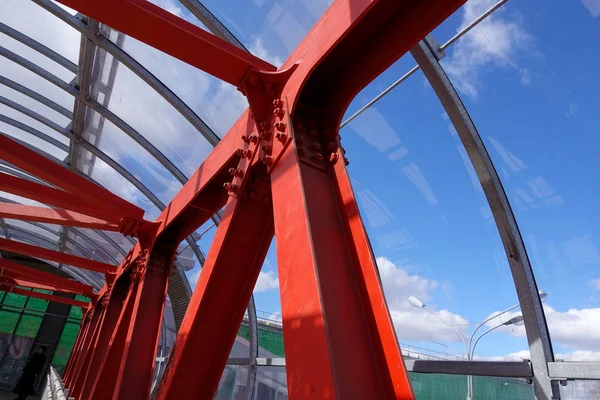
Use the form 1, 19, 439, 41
377, 257, 468, 342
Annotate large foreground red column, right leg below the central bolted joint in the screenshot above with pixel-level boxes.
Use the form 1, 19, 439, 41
271, 121, 413, 400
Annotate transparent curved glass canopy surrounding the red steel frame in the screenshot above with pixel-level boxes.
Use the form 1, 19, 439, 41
0, 0, 600, 399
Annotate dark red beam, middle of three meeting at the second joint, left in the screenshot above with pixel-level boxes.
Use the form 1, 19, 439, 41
0, 172, 123, 220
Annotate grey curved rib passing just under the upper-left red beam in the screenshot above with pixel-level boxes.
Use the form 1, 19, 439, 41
32, 0, 220, 146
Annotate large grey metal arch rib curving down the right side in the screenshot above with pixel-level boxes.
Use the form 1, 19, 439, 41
411, 41, 560, 400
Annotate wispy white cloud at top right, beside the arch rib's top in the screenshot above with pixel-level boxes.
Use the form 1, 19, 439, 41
443, 0, 532, 98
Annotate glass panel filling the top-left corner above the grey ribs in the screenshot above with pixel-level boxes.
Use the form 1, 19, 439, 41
0, 0, 81, 64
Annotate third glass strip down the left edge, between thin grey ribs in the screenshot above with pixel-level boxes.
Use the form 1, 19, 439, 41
0, 57, 74, 110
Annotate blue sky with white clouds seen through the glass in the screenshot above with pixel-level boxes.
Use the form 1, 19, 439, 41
0, 0, 600, 360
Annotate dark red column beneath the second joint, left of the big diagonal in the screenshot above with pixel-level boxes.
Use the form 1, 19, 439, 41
113, 243, 177, 400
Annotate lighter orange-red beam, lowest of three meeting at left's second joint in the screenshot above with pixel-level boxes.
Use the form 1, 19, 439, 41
0, 203, 119, 232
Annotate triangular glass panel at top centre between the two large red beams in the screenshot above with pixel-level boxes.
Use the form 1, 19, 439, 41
202, 0, 331, 62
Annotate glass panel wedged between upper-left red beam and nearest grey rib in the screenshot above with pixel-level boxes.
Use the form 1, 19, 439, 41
115, 30, 248, 137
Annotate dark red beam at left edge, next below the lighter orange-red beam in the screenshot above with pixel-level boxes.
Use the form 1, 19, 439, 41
0, 238, 117, 273
